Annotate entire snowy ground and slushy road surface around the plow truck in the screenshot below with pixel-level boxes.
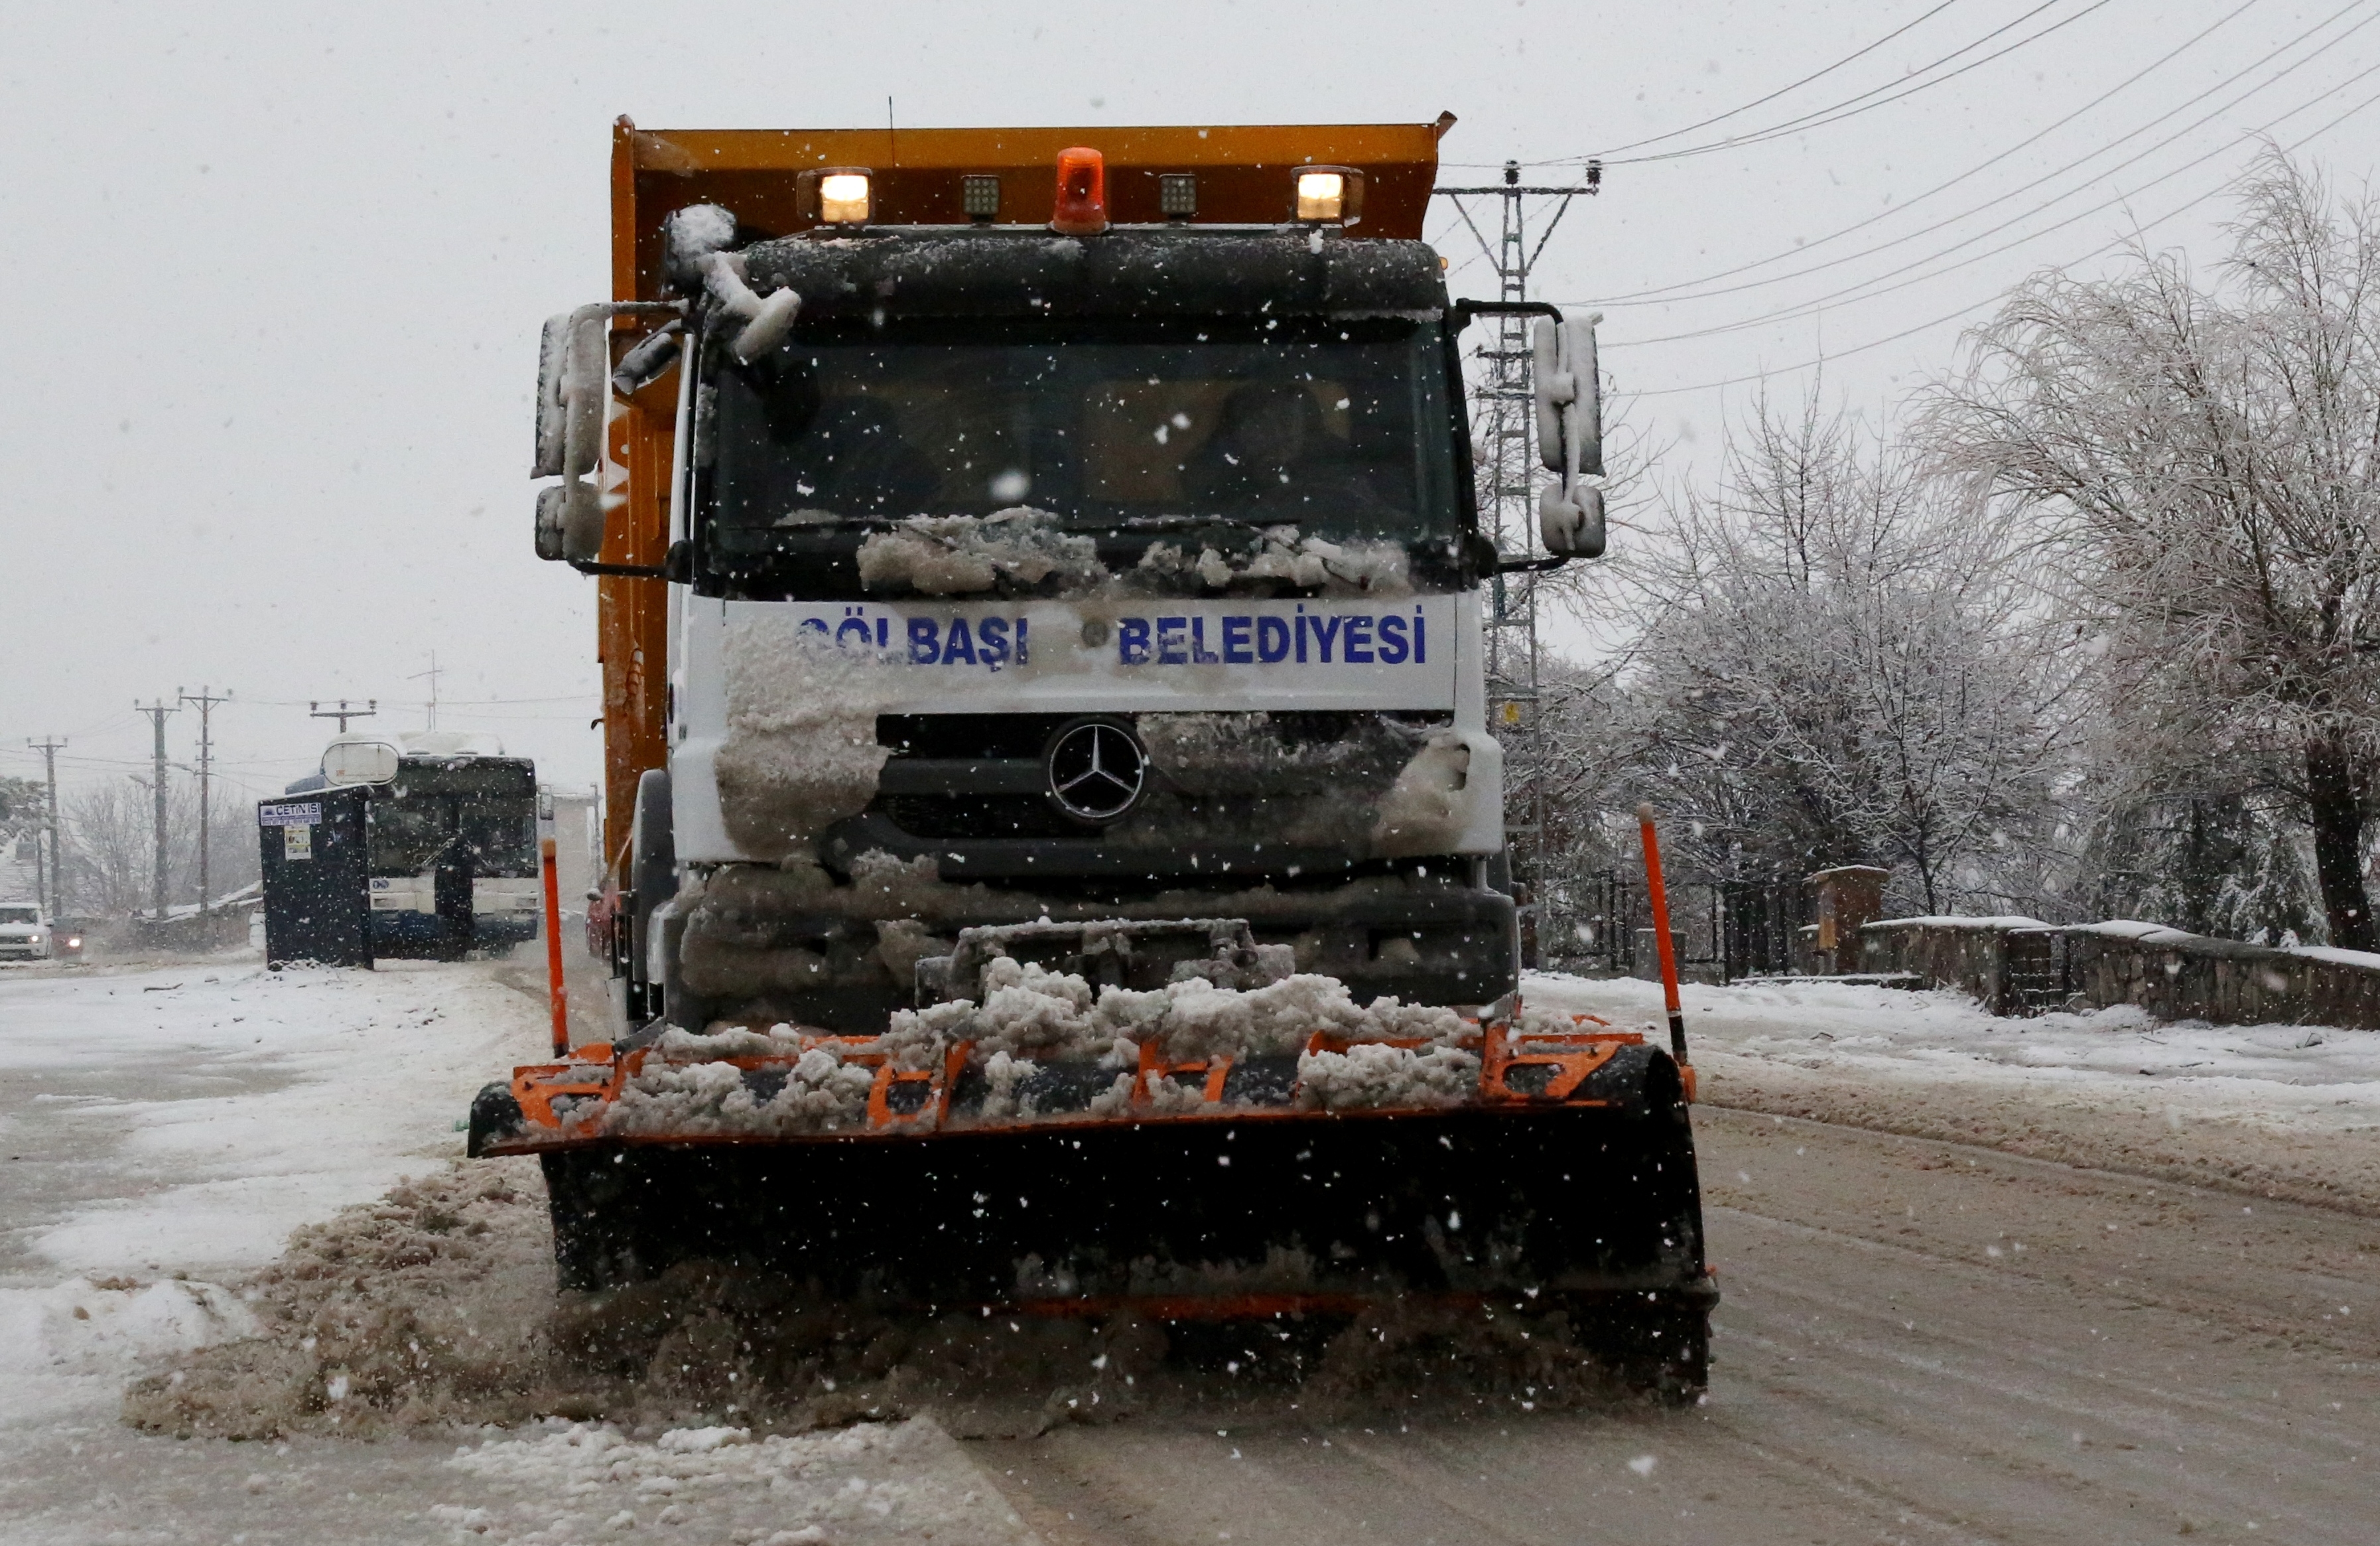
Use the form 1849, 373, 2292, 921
0, 965, 2380, 1546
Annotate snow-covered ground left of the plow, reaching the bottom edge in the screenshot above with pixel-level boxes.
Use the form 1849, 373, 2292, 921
0, 957, 1031, 1546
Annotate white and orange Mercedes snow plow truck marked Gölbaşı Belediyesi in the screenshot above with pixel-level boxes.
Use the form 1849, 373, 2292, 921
471, 117, 1716, 1396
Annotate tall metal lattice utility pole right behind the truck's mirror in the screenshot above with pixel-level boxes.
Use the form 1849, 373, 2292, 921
1433, 162, 1604, 967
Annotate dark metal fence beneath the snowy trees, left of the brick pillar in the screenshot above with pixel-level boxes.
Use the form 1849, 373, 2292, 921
1526, 869, 1816, 981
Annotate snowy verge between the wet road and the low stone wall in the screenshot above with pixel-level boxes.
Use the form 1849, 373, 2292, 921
1521, 974, 2380, 1215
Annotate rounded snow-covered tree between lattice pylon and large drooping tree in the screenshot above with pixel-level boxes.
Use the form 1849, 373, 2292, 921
1571, 400, 2059, 910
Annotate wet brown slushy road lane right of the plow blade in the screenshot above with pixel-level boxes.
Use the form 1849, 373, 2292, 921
971, 1107, 2380, 1546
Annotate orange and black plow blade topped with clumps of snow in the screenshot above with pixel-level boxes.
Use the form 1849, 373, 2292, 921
471, 924, 1716, 1332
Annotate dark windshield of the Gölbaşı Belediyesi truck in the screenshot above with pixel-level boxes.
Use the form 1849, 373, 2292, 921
707, 319, 1454, 581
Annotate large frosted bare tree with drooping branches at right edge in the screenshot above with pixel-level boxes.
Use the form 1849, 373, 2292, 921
1926, 153, 2380, 948
